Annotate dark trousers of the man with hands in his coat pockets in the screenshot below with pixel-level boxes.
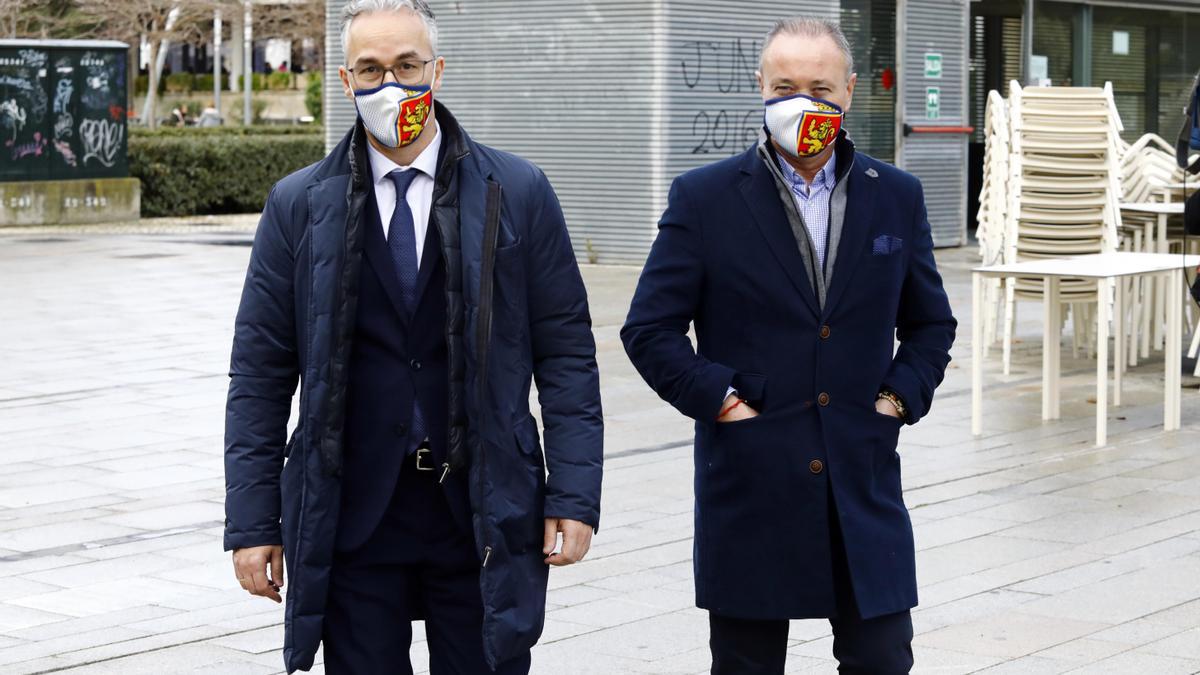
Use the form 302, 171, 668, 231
708, 487, 912, 675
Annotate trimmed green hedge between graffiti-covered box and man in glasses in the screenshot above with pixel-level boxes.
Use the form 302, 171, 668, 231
130, 127, 325, 217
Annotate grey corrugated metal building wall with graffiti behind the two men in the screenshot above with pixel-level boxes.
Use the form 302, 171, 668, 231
324, 0, 972, 264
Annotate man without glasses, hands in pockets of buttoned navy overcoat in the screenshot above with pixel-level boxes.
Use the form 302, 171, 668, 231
622, 18, 956, 675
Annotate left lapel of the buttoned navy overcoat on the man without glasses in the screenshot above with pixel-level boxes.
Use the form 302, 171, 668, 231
739, 149, 821, 315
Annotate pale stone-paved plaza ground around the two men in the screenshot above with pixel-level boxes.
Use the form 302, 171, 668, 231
0, 217, 1200, 675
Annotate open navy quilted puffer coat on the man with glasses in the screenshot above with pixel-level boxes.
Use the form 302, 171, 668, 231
224, 106, 604, 673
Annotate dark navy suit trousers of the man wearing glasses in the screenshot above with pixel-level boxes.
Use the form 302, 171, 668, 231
323, 456, 529, 675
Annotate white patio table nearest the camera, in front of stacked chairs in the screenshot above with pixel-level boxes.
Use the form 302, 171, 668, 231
971, 252, 1200, 446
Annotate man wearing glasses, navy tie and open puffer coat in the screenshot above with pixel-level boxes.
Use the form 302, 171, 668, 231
224, 0, 602, 674
